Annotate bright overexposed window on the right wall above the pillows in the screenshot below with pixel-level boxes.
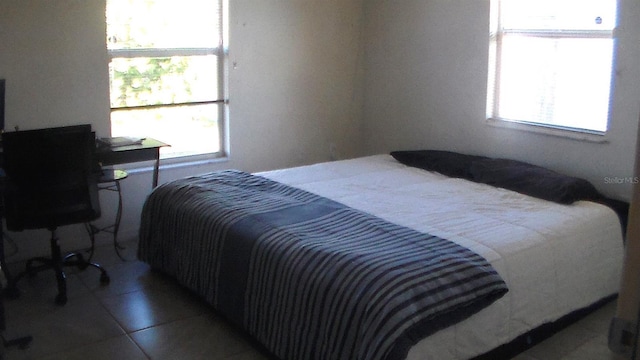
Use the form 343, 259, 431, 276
487, 0, 617, 134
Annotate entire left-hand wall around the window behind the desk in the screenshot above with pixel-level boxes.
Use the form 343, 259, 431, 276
0, 0, 363, 260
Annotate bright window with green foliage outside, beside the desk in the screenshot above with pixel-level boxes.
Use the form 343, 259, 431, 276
106, 0, 228, 158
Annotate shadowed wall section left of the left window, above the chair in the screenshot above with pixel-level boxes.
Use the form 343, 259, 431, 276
0, 0, 109, 133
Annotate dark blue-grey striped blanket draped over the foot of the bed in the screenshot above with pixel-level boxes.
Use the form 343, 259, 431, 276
138, 170, 507, 360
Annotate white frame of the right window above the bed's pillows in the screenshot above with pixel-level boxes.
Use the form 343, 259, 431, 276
486, 0, 619, 142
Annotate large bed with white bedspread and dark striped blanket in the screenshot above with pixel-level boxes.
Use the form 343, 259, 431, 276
138, 152, 623, 360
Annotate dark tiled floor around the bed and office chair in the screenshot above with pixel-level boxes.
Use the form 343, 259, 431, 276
0, 239, 615, 360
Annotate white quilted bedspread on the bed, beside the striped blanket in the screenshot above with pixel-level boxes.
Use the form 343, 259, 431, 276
258, 155, 623, 360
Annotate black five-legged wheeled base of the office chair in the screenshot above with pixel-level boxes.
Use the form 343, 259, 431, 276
5, 229, 111, 305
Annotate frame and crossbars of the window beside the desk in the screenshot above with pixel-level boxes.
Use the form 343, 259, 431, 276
107, 0, 229, 160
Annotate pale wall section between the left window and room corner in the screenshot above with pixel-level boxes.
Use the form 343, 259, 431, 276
230, 0, 362, 170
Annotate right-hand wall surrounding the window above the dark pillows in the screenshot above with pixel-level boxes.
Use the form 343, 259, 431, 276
363, 0, 640, 199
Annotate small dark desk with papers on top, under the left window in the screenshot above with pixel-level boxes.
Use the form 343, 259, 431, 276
96, 138, 169, 188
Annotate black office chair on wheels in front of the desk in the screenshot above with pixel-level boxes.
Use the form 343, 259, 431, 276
2, 125, 110, 305
